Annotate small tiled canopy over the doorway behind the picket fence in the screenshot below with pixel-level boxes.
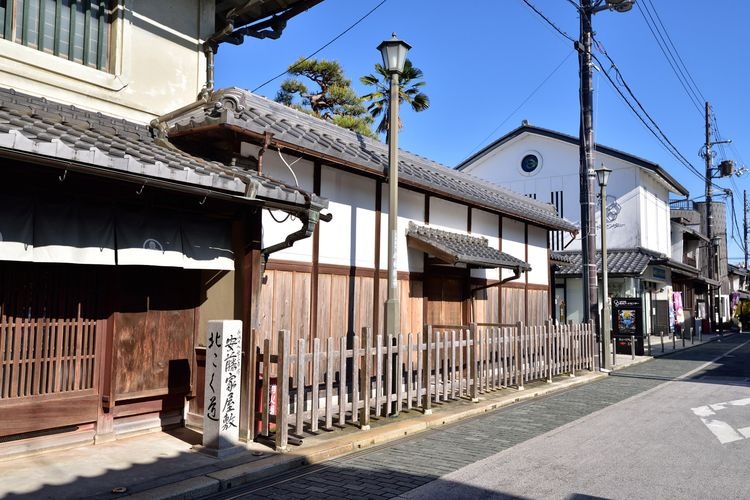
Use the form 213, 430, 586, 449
406, 222, 531, 271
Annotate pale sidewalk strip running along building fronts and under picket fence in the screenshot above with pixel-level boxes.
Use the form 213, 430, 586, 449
0, 335, 736, 499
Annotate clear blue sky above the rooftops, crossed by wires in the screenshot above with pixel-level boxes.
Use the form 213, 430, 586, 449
216, 0, 750, 262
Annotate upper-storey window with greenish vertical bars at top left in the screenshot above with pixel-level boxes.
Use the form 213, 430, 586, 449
0, 0, 117, 71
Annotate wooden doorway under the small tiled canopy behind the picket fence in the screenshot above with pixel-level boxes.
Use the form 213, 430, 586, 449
425, 265, 469, 325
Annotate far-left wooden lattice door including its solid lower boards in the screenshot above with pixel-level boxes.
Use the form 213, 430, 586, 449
0, 262, 106, 436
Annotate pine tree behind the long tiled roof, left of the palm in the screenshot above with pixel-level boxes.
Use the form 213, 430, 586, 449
276, 58, 374, 137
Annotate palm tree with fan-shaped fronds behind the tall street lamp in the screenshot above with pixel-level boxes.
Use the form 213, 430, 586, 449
359, 58, 430, 134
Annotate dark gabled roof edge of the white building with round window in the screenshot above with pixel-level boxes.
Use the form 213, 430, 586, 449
456, 125, 689, 196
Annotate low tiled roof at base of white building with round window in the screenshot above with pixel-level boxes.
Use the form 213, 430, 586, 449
550, 248, 664, 276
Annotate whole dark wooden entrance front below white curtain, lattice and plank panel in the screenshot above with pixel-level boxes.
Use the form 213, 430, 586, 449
0, 262, 200, 442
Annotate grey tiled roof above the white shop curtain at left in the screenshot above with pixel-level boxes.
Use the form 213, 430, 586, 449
0, 88, 318, 205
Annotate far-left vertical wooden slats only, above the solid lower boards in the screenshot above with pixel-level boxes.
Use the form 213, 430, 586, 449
0, 264, 101, 401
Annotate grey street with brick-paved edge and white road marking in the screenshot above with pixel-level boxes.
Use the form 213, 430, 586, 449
213, 334, 750, 499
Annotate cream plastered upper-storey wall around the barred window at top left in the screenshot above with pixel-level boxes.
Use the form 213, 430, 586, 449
0, 0, 214, 123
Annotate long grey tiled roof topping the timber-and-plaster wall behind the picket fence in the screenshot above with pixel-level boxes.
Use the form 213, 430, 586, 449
165, 88, 576, 231
